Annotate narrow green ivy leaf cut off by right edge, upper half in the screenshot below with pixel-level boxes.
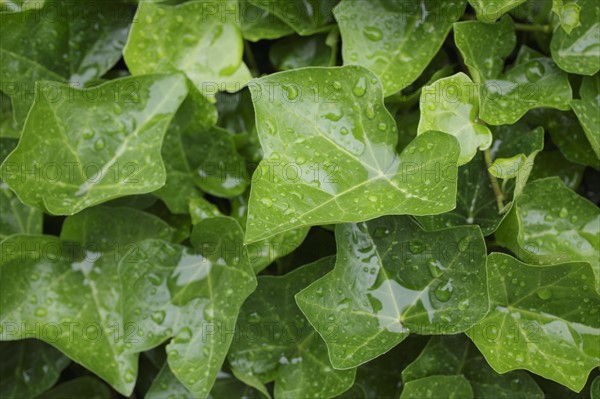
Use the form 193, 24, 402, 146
571, 74, 600, 159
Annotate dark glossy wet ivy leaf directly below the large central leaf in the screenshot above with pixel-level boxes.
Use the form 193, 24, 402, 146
296, 216, 488, 369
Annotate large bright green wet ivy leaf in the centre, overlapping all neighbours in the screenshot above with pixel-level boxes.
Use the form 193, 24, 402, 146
246, 66, 459, 243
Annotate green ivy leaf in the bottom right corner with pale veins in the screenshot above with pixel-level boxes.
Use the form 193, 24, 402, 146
467, 253, 600, 392
